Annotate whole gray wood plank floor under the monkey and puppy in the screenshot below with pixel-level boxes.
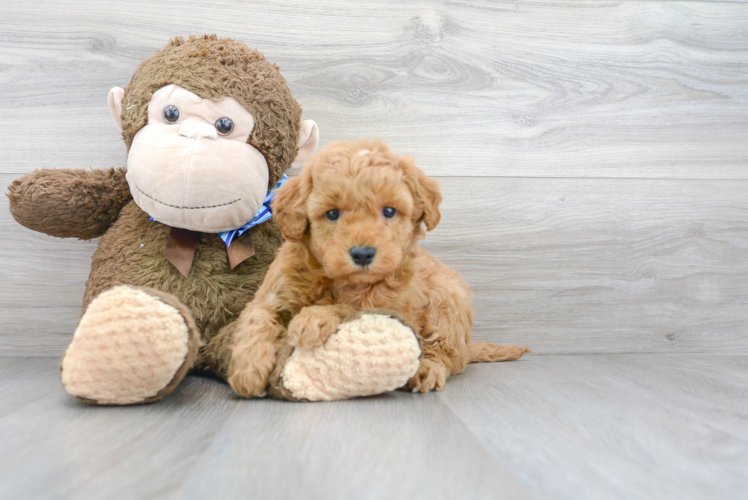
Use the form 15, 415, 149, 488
0, 354, 748, 500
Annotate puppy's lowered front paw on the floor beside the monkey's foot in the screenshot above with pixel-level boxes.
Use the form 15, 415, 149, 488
227, 342, 275, 398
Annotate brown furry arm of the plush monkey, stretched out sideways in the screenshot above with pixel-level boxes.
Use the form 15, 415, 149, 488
7, 168, 132, 240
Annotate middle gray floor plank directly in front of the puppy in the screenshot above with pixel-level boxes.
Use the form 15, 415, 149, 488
179, 382, 529, 500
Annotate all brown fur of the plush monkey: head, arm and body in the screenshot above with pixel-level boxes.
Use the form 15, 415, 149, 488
8, 35, 301, 384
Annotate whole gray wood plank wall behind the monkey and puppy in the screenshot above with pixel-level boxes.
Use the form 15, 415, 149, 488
0, 0, 748, 356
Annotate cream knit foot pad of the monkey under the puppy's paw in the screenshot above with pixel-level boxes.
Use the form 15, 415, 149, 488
281, 314, 421, 401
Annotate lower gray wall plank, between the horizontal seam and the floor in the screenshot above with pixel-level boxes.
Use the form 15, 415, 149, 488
0, 174, 748, 356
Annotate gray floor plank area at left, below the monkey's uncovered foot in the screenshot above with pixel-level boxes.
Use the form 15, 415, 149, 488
0, 358, 237, 499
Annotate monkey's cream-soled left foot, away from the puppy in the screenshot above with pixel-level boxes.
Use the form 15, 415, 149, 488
60, 286, 200, 405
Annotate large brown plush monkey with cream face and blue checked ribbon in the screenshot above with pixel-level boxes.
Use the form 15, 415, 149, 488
8, 35, 419, 405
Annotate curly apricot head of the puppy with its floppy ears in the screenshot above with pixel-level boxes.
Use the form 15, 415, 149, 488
273, 141, 441, 283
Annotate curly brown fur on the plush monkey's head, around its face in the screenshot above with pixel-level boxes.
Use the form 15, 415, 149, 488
122, 35, 301, 187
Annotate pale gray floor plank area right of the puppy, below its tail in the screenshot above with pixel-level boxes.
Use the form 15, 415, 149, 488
444, 355, 748, 499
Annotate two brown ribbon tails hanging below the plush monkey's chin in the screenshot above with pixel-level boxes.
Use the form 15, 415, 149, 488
164, 227, 255, 278
